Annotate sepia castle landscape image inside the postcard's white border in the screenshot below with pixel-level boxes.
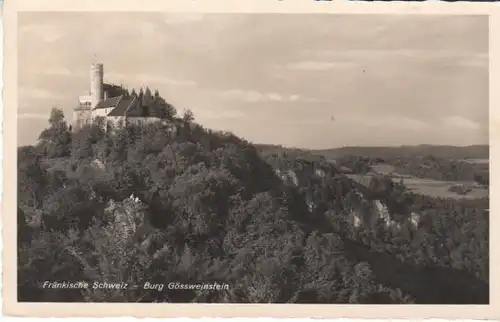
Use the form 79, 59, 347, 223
12, 11, 490, 313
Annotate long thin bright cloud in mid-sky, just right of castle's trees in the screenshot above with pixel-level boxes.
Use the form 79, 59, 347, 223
215, 89, 321, 103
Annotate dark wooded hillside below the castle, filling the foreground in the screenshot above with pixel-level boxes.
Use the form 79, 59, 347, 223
17, 98, 489, 304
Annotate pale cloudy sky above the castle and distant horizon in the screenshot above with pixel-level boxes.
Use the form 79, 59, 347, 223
18, 12, 488, 149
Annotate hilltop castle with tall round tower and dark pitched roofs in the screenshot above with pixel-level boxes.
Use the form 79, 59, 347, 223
73, 63, 167, 129
